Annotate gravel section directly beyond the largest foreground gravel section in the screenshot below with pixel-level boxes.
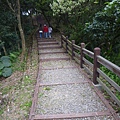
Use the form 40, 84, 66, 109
39, 68, 85, 84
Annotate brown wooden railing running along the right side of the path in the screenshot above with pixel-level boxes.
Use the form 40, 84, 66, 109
61, 35, 120, 106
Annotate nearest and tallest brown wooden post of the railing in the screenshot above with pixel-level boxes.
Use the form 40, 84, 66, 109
93, 47, 100, 85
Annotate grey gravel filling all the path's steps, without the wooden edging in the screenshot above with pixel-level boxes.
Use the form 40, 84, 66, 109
35, 37, 118, 120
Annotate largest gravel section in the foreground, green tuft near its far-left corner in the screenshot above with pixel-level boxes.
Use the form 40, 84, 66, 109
36, 83, 107, 114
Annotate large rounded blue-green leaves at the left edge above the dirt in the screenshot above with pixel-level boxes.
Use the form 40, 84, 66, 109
0, 56, 12, 77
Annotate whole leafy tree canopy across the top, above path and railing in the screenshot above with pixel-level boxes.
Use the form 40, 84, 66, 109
0, 0, 120, 65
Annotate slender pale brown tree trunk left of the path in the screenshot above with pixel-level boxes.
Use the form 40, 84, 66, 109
17, 0, 25, 61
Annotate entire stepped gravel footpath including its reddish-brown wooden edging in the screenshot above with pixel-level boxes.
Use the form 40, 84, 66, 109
29, 38, 119, 120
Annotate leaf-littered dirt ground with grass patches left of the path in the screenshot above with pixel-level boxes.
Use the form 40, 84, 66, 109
0, 34, 38, 120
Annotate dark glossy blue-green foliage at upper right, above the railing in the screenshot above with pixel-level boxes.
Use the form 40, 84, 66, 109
85, 0, 120, 55
